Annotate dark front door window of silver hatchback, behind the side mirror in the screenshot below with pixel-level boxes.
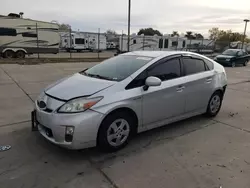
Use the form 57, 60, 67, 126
148, 58, 181, 81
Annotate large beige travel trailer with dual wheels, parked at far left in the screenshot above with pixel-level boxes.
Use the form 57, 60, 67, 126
0, 16, 60, 58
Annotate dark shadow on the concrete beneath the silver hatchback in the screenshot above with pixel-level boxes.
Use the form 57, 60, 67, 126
19, 115, 215, 166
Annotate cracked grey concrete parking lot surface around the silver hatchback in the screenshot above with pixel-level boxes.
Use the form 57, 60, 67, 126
0, 63, 250, 188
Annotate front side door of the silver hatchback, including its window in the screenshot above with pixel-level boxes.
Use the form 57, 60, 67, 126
142, 57, 185, 128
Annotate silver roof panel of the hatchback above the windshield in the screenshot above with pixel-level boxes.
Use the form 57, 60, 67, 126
123, 51, 204, 58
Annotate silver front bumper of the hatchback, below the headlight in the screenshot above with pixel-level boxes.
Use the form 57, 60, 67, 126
35, 103, 104, 150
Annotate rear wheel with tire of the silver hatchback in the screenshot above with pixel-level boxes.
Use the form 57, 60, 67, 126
206, 91, 223, 117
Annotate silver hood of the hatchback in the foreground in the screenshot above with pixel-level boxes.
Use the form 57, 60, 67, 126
45, 73, 115, 100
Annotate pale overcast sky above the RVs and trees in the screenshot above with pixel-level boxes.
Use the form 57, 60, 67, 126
0, 0, 250, 35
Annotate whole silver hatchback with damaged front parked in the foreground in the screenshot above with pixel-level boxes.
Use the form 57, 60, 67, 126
32, 51, 227, 151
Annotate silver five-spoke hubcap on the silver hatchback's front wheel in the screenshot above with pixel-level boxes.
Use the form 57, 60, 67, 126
107, 119, 130, 146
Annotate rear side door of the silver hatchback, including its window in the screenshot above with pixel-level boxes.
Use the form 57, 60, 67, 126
182, 56, 215, 113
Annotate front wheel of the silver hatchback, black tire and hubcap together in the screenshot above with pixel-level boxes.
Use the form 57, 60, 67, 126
97, 111, 136, 152
